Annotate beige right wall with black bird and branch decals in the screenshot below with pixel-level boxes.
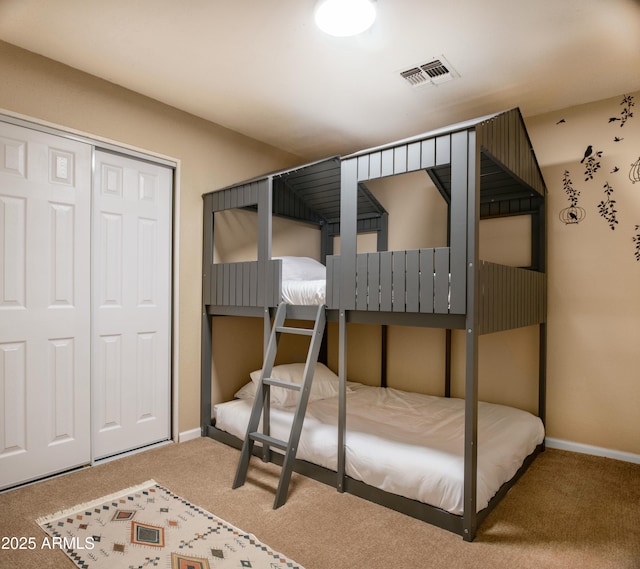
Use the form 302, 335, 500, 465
526, 92, 640, 454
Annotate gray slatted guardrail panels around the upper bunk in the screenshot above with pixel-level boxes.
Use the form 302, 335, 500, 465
209, 252, 546, 328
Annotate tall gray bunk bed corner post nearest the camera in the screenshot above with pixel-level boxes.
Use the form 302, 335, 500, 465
460, 131, 480, 541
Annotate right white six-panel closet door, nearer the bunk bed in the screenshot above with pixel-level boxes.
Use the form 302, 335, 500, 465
92, 152, 173, 458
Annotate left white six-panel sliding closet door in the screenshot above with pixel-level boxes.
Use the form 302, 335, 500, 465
0, 122, 92, 488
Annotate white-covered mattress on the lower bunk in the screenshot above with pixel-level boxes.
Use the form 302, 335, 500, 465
214, 384, 544, 514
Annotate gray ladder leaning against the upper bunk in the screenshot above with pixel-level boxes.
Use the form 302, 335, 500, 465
233, 303, 326, 509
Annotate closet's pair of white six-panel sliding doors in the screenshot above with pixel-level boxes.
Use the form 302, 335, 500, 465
0, 121, 173, 488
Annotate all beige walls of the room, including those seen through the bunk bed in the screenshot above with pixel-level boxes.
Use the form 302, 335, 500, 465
0, 38, 640, 454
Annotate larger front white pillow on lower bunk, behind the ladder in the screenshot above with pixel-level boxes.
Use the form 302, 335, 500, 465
249, 363, 349, 407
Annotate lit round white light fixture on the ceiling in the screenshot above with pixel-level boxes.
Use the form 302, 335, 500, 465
315, 0, 376, 37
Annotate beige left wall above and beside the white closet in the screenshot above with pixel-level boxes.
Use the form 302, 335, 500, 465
0, 42, 300, 432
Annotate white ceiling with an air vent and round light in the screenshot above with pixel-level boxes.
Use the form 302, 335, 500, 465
0, 0, 640, 159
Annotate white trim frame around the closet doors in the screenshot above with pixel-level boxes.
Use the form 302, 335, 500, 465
0, 109, 180, 458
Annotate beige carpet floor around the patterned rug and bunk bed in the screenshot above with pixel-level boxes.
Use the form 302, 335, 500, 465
0, 439, 640, 569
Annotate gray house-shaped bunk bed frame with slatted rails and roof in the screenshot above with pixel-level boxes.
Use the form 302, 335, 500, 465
201, 108, 546, 541
